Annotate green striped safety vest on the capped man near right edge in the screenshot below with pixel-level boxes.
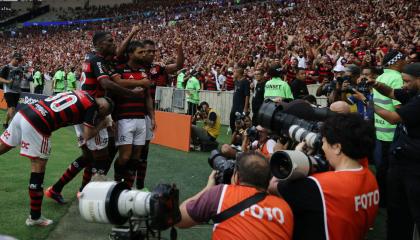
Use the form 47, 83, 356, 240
373, 69, 403, 142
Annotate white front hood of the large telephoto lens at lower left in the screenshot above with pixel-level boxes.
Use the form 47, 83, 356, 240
79, 182, 117, 223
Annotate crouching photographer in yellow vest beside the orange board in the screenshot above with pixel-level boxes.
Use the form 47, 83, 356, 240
191, 102, 221, 149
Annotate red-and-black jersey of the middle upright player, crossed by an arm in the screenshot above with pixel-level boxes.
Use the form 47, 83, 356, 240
112, 64, 149, 120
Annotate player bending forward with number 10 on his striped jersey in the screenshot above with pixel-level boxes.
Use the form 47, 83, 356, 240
0, 91, 114, 226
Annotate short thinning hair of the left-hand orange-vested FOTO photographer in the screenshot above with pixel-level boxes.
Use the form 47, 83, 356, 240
236, 151, 271, 189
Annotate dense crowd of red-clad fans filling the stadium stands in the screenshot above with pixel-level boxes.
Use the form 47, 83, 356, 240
0, 1, 419, 92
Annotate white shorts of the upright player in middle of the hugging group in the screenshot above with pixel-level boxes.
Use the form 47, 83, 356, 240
115, 118, 146, 146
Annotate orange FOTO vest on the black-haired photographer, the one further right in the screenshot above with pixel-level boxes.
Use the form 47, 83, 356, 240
309, 167, 379, 240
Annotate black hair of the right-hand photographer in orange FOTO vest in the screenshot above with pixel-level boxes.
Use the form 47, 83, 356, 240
321, 113, 376, 160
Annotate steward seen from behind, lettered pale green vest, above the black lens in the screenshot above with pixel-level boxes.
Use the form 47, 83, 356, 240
264, 65, 293, 99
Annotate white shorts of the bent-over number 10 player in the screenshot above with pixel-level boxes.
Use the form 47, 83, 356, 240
0, 112, 51, 159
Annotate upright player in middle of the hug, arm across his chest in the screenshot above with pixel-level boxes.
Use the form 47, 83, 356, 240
113, 41, 154, 187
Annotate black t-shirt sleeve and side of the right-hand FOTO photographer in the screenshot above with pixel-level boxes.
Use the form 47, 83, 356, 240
278, 178, 326, 240
